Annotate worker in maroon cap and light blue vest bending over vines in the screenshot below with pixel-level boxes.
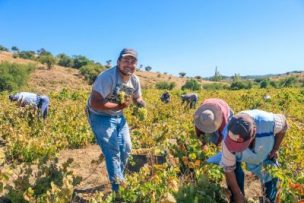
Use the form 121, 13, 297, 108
221, 110, 287, 203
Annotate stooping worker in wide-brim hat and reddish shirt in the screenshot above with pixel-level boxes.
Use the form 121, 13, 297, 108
194, 98, 233, 152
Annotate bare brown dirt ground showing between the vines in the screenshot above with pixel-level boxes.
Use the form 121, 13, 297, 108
59, 145, 261, 202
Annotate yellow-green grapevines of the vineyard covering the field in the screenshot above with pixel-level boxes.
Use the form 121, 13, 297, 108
0, 88, 304, 202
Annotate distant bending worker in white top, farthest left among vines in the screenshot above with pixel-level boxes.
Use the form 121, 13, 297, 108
9, 92, 50, 119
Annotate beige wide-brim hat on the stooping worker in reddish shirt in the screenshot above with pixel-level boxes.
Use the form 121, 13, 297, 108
194, 103, 223, 133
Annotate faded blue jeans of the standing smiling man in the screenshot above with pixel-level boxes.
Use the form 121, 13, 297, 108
89, 112, 132, 191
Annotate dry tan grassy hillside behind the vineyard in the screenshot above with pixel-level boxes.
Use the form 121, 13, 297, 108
0, 52, 209, 93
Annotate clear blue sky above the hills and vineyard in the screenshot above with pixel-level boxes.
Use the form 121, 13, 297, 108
0, 0, 304, 77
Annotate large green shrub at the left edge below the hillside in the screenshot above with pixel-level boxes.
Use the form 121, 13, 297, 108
0, 62, 35, 91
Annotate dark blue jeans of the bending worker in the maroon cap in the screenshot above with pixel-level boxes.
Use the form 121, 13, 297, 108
228, 162, 278, 203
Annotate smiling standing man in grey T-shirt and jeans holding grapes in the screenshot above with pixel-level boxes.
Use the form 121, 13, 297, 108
87, 49, 145, 192
